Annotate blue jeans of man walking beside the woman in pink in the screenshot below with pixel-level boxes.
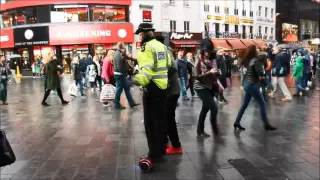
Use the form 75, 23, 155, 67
114, 75, 134, 107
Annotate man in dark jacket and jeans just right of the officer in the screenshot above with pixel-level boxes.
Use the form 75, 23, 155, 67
176, 51, 190, 101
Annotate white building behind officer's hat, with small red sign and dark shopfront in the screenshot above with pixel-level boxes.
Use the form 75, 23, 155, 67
130, 0, 202, 53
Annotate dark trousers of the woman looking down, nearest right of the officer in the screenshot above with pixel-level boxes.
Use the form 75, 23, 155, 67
196, 89, 218, 135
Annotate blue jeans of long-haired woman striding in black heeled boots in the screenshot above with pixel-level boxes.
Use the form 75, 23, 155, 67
236, 82, 268, 125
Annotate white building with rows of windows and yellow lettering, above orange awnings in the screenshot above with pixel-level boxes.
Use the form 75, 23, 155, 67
200, 0, 275, 40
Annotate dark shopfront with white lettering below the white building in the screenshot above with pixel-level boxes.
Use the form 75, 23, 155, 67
169, 32, 202, 54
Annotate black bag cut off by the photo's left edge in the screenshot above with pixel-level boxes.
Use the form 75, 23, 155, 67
0, 129, 16, 167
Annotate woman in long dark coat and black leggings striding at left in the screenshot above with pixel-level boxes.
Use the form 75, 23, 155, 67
42, 51, 69, 106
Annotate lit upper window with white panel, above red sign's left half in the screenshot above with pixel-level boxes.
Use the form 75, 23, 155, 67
50, 5, 88, 23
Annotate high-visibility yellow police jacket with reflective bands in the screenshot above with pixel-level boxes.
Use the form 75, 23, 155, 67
134, 39, 173, 89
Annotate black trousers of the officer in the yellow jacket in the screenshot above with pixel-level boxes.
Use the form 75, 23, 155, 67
143, 82, 167, 160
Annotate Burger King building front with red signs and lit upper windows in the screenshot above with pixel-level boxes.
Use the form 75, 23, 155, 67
0, 0, 134, 72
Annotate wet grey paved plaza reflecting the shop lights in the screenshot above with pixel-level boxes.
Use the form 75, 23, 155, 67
0, 77, 320, 180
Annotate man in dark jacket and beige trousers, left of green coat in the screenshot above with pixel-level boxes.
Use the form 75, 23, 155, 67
269, 47, 292, 102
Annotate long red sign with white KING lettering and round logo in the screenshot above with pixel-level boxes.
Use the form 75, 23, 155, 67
49, 23, 134, 45
